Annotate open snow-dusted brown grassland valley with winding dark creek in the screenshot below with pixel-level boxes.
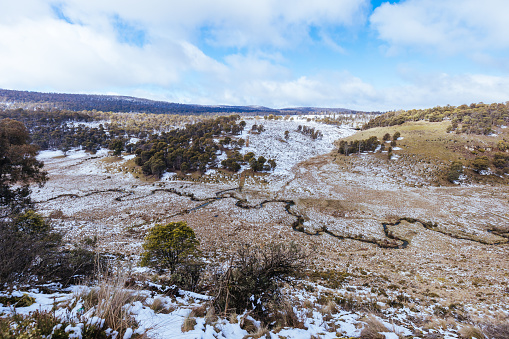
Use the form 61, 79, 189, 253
33, 120, 509, 338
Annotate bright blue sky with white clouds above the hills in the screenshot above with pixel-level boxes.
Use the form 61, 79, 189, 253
0, 0, 509, 111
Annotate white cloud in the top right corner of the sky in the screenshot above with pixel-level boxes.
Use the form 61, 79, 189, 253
370, 0, 509, 55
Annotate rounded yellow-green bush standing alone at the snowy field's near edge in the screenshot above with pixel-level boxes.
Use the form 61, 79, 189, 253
141, 221, 199, 274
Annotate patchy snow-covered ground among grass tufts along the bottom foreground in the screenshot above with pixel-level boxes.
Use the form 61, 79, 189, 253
0, 284, 459, 339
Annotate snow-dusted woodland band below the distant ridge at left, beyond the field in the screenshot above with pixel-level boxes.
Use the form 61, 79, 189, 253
0, 109, 211, 155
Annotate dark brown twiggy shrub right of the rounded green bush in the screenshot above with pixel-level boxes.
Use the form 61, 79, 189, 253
214, 243, 307, 315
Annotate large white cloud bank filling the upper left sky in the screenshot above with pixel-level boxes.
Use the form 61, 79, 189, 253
0, 0, 369, 92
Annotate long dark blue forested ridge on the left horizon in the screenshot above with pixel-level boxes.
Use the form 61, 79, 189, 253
0, 89, 353, 115
